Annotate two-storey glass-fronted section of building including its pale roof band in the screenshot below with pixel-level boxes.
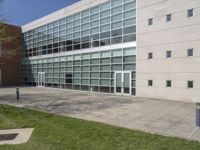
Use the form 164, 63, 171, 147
22, 0, 136, 95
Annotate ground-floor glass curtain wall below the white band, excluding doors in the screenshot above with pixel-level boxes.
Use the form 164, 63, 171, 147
23, 47, 136, 95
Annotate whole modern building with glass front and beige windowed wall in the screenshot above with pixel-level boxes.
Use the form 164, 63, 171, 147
22, 0, 200, 101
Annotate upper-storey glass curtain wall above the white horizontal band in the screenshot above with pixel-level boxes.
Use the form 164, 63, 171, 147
24, 0, 136, 57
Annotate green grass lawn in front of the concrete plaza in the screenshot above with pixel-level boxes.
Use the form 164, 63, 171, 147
0, 105, 200, 150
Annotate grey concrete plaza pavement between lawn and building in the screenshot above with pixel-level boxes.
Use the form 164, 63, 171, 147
0, 87, 200, 141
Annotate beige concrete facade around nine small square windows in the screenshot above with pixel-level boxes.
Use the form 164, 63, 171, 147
136, 0, 200, 102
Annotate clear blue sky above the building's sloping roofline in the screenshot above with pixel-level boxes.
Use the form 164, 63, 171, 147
0, 0, 79, 26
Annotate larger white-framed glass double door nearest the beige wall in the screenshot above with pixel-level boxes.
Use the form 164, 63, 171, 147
114, 71, 131, 95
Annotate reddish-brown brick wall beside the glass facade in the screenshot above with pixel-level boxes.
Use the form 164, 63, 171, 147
0, 23, 22, 87
